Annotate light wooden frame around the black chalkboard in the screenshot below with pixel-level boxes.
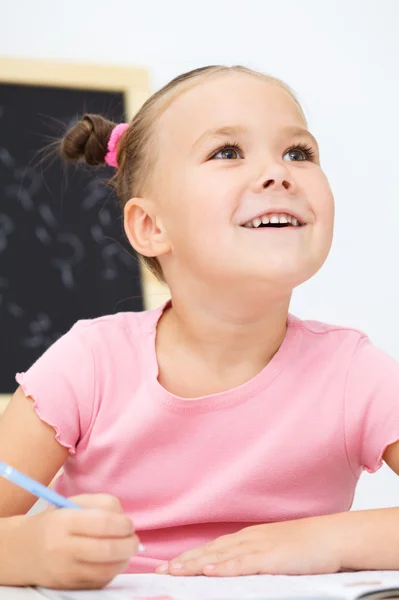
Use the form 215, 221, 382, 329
0, 57, 170, 412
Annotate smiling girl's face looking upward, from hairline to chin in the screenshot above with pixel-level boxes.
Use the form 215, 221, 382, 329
154, 73, 334, 293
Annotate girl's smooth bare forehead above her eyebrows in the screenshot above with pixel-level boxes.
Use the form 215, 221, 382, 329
157, 73, 306, 147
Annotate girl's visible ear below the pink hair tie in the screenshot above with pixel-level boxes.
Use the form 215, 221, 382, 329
123, 198, 171, 257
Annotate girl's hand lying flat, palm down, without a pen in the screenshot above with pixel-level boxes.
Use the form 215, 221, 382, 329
157, 517, 341, 577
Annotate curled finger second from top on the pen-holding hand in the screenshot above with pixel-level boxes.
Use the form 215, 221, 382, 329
60, 508, 134, 538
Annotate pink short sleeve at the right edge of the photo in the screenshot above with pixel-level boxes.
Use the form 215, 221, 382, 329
345, 337, 399, 473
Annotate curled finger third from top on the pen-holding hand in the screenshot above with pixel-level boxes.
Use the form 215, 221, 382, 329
70, 535, 139, 563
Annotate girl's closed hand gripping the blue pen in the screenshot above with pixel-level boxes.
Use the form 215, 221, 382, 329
16, 494, 139, 589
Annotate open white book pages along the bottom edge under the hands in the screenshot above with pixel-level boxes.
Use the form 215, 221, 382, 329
35, 571, 399, 600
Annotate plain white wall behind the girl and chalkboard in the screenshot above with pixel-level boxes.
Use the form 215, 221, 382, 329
0, 0, 399, 508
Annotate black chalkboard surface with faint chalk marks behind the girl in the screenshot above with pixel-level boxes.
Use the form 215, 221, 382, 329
0, 84, 143, 394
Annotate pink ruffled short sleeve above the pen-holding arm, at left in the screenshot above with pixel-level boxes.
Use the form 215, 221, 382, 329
15, 321, 95, 454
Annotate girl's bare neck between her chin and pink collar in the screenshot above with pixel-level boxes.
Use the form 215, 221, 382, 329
159, 288, 291, 374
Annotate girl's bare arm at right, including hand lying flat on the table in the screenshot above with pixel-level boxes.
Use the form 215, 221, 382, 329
157, 442, 399, 576
